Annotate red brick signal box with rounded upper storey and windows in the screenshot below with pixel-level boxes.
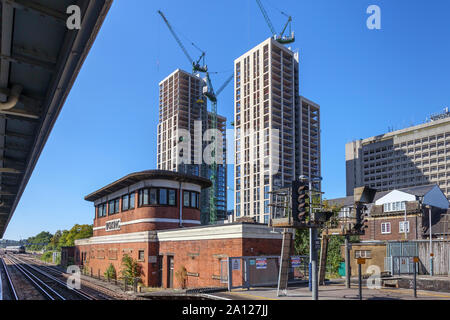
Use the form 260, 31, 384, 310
73, 170, 282, 288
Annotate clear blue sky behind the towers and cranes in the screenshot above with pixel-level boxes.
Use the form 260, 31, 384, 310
1, 0, 450, 239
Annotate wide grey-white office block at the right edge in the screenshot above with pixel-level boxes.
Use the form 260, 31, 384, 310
345, 110, 450, 199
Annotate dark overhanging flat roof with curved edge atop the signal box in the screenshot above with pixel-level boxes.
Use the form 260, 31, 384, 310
84, 170, 212, 201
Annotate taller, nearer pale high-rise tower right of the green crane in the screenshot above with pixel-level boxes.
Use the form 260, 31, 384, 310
234, 38, 320, 223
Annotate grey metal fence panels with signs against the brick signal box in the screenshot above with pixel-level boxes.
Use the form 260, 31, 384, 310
227, 256, 308, 291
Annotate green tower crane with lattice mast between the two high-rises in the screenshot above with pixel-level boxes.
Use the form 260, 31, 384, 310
203, 72, 234, 224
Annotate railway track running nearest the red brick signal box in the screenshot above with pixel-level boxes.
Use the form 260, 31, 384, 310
5, 256, 96, 300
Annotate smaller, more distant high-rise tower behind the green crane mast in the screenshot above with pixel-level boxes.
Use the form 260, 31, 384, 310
157, 69, 227, 224
